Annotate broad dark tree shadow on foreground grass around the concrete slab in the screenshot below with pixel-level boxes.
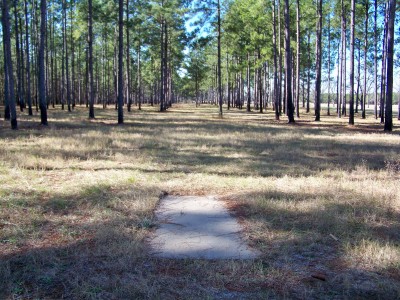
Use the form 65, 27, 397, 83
0, 186, 400, 299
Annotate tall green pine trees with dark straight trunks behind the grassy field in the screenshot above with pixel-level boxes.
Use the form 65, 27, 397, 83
0, 0, 400, 131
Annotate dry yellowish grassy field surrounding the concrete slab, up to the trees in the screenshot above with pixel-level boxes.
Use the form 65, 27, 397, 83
0, 105, 400, 299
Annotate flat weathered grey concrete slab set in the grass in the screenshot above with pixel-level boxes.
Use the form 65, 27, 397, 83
150, 196, 258, 259
